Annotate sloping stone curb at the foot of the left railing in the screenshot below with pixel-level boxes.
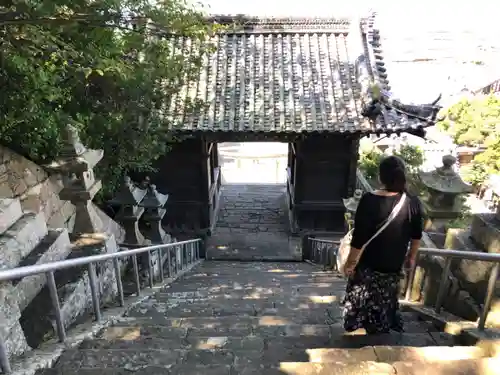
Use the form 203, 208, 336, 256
5, 259, 204, 375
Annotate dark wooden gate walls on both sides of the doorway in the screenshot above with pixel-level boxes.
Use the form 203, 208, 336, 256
145, 135, 359, 235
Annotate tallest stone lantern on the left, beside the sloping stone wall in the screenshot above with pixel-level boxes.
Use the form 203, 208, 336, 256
47, 125, 103, 234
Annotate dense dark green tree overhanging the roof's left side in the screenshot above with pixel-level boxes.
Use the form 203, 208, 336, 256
0, 0, 217, 197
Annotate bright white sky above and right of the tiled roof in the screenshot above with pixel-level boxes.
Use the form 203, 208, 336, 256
198, 0, 500, 102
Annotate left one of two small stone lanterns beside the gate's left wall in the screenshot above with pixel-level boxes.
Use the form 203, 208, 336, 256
109, 176, 147, 247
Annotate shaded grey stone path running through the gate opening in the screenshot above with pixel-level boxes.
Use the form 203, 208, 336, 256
207, 184, 302, 260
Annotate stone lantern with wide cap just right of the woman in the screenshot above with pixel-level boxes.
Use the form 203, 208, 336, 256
419, 155, 473, 219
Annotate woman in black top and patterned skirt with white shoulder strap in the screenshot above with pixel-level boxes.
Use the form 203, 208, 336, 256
344, 156, 423, 334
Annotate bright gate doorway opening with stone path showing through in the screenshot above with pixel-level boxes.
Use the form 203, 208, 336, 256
207, 142, 301, 260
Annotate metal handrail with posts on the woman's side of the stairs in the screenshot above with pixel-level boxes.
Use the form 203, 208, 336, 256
308, 237, 500, 331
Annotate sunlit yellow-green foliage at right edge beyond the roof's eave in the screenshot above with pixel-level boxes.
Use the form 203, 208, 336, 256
439, 94, 500, 185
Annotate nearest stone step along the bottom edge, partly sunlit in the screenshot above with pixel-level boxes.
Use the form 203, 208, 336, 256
43, 348, 500, 375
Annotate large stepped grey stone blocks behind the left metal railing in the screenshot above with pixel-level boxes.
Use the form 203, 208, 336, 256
0, 199, 117, 357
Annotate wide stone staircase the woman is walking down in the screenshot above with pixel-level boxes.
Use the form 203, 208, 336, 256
38, 261, 500, 375
